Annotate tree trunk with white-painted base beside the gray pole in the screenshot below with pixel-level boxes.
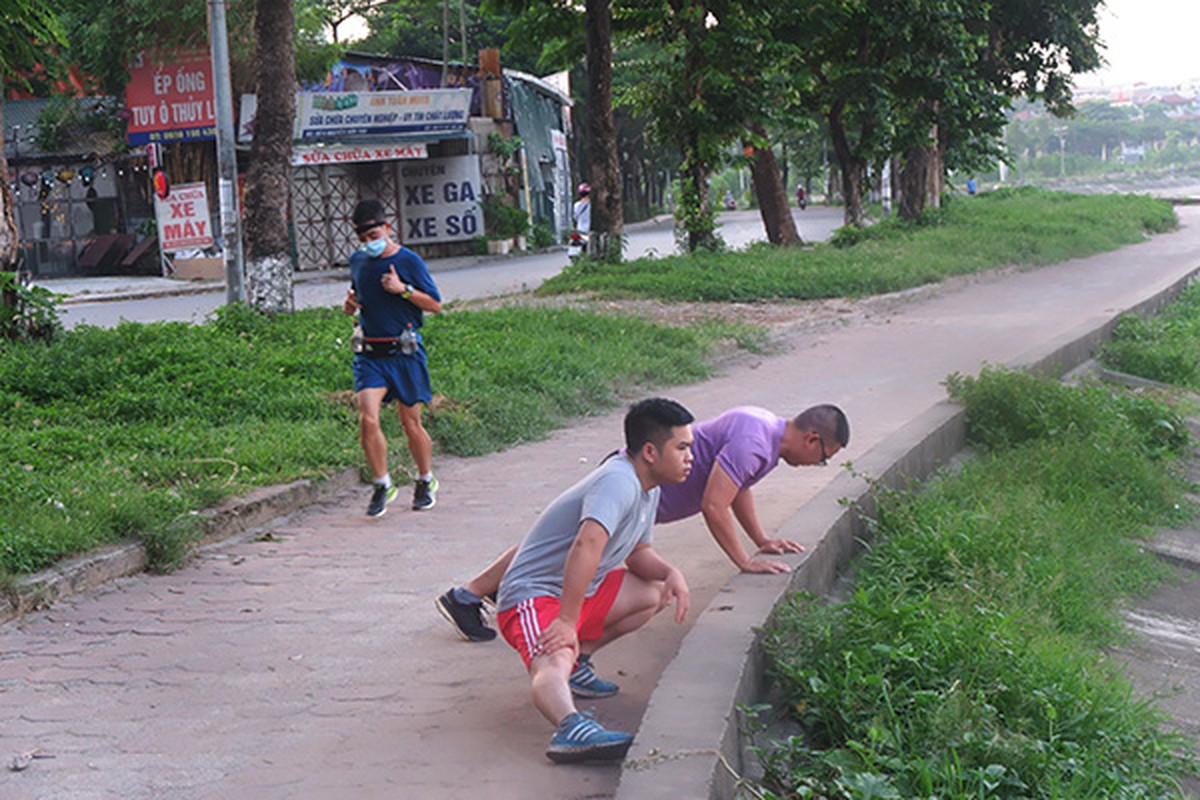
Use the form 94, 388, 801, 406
245, 0, 295, 314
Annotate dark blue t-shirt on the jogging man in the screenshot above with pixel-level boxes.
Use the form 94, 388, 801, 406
350, 247, 442, 338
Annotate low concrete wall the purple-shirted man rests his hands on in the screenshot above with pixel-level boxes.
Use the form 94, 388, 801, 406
616, 270, 1200, 800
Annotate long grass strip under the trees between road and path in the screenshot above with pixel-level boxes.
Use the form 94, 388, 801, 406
538, 188, 1177, 302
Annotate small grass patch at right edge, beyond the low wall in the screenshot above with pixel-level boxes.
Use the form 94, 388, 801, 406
1099, 283, 1200, 392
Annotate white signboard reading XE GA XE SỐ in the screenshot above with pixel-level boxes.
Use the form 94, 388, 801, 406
400, 156, 484, 247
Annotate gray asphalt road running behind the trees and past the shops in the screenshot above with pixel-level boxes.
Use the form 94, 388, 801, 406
56, 206, 842, 327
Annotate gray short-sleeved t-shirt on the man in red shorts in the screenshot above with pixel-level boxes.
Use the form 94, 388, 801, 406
497, 456, 659, 610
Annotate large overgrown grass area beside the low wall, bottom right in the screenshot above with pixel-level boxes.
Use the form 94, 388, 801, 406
760, 369, 1194, 798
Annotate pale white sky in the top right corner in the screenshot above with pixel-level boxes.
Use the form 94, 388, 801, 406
1076, 0, 1200, 86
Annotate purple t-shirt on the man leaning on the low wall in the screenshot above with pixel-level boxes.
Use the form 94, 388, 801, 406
655, 405, 787, 522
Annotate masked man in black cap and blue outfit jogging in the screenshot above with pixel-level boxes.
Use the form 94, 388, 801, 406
342, 199, 442, 517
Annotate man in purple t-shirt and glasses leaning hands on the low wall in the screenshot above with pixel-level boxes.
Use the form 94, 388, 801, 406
434, 404, 850, 642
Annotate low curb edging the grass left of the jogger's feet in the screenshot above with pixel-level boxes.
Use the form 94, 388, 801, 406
0, 467, 359, 624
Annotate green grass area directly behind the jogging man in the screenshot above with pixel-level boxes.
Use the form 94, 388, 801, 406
0, 308, 716, 581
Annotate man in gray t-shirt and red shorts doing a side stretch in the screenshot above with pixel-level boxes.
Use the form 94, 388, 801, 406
497, 397, 692, 763
